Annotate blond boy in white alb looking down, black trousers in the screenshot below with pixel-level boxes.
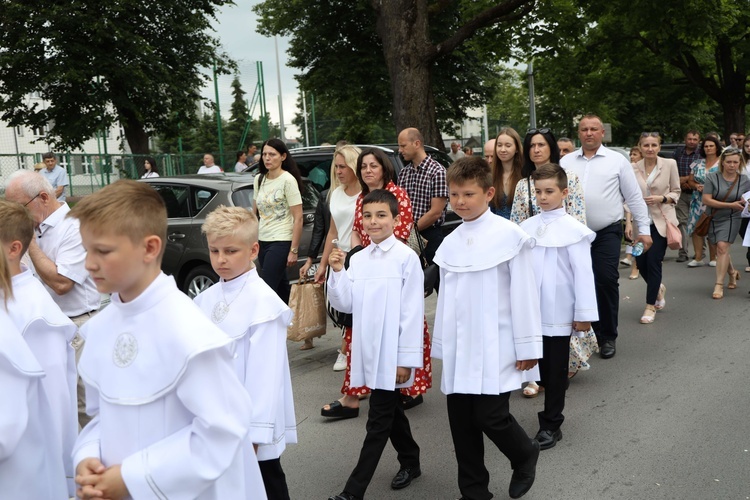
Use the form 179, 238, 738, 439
195, 206, 297, 500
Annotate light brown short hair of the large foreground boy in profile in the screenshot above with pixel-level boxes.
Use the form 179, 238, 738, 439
68, 179, 167, 261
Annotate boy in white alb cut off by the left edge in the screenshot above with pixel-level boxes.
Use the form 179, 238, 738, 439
0, 253, 68, 500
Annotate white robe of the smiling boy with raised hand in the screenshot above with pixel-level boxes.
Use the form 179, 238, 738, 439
328, 235, 424, 391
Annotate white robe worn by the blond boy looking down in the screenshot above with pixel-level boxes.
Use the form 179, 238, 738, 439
195, 268, 297, 460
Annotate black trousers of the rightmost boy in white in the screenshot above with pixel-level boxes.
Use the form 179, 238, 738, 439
538, 335, 570, 431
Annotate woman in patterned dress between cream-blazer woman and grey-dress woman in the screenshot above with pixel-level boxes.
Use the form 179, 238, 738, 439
685, 135, 721, 267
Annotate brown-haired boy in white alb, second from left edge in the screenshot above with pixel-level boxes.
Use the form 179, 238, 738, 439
0, 200, 78, 496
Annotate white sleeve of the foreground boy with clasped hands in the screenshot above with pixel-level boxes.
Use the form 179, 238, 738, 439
121, 349, 251, 499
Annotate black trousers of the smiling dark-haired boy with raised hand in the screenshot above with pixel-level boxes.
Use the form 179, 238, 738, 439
344, 389, 419, 498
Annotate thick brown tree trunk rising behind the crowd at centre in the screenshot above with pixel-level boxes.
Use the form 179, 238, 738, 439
373, 0, 444, 149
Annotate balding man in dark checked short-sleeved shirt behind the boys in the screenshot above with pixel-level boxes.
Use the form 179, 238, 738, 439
398, 128, 448, 263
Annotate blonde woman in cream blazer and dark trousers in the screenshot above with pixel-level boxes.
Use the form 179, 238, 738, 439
636, 132, 680, 324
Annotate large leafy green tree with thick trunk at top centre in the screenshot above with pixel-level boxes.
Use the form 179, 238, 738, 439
254, 0, 534, 146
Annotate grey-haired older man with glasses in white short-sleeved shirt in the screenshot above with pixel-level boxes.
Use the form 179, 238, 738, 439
5, 170, 101, 426
